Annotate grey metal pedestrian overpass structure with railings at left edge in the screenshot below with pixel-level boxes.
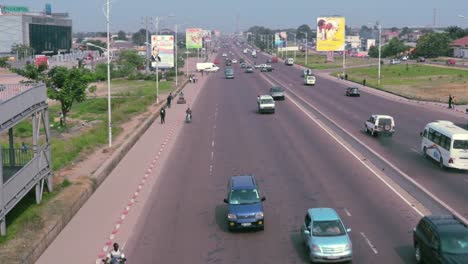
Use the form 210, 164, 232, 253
0, 83, 52, 235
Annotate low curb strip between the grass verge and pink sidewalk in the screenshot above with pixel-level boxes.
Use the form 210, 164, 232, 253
20, 80, 188, 263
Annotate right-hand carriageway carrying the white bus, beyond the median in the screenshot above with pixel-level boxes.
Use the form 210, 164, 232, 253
249, 48, 468, 221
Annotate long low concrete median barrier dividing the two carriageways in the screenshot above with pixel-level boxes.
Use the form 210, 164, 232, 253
262, 69, 468, 223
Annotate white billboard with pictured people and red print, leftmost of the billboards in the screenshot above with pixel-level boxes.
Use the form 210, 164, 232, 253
151, 35, 174, 68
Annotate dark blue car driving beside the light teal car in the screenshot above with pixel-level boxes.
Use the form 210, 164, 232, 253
224, 175, 265, 231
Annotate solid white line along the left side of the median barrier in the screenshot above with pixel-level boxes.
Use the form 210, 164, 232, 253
262, 75, 424, 219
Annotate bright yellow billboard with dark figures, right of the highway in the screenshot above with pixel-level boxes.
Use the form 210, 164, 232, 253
317, 17, 345, 51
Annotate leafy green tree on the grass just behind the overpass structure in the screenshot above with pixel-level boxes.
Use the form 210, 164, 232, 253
46, 66, 91, 123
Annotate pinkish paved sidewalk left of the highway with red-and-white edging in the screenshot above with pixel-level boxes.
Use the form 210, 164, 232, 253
37, 54, 216, 264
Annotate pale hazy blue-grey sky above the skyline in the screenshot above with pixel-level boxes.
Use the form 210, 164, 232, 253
5, 0, 468, 32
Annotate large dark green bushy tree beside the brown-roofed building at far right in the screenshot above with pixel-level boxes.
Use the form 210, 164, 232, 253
416, 33, 451, 58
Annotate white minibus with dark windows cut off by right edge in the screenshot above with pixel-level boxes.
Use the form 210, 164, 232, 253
421, 120, 468, 170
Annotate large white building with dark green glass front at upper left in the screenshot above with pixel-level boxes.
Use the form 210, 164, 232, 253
0, 5, 72, 54
